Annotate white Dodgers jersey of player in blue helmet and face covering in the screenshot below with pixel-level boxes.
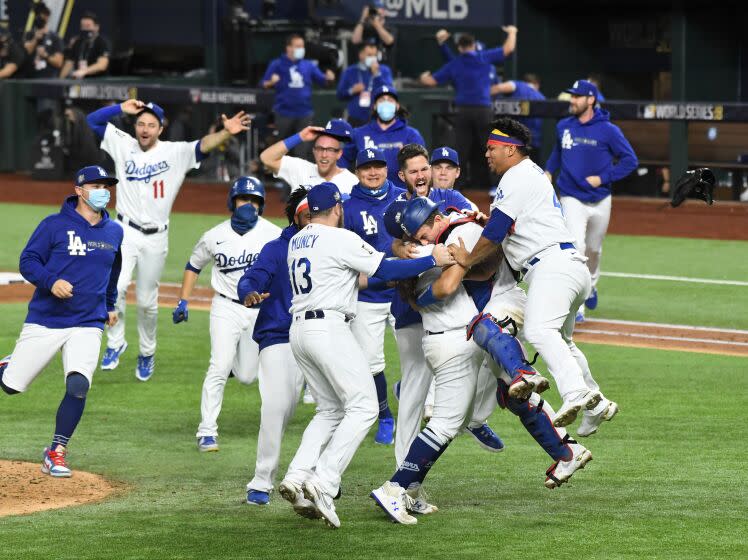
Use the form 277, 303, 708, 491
190, 218, 281, 299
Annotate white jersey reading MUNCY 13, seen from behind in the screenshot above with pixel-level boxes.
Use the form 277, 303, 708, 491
288, 224, 384, 316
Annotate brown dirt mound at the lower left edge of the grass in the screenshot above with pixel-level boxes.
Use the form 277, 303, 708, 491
0, 460, 116, 517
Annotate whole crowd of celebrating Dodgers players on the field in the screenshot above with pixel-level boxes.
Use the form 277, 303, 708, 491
0, 61, 636, 527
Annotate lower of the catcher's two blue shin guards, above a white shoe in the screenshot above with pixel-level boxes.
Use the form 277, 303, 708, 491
496, 380, 573, 461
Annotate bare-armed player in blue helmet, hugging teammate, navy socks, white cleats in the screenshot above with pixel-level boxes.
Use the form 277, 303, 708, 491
371, 197, 496, 525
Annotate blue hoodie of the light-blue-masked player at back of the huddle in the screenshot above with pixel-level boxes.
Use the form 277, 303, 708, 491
338, 118, 426, 188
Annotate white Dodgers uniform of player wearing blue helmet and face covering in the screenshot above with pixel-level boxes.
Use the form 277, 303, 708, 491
189, 218, 281, 437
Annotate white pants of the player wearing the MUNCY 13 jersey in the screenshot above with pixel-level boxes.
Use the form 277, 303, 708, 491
286, 310, 379, 496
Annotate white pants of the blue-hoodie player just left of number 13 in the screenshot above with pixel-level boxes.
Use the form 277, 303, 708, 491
247, 343, 304, 492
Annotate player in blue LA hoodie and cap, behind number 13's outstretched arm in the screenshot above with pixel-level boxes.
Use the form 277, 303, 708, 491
343, 148, 405, 445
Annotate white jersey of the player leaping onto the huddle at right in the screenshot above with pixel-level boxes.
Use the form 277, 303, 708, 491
491, 159, 574, 270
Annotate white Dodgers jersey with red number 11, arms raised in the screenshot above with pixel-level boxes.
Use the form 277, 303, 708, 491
101, 123, 200, 227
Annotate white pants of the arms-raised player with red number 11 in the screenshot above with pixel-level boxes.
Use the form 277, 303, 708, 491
107, 224, 169, 356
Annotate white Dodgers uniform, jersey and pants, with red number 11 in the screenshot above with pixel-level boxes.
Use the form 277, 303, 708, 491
101, 123, 200, 356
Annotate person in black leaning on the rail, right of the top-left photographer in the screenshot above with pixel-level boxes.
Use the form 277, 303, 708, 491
60, 12, 110, 80
